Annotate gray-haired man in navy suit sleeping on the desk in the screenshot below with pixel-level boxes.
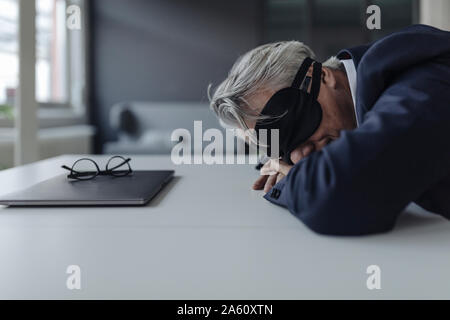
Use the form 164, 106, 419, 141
211, 25, 450, 235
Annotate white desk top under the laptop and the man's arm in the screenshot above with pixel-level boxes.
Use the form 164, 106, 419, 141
0, 156, 450, 299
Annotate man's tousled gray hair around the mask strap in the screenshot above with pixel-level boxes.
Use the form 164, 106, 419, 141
208, 41, 342, 130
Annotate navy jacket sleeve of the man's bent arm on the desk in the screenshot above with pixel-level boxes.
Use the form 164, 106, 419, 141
265, 63, 450, 235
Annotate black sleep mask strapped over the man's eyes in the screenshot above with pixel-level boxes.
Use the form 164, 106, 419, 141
255, 58, 322, 164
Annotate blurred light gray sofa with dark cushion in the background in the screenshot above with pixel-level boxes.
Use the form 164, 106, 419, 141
103, 102, 225, 154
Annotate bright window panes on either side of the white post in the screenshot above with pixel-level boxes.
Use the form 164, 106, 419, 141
0, 0, 86, 117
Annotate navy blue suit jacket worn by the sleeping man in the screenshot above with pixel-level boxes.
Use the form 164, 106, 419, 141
265, 25, 450, 235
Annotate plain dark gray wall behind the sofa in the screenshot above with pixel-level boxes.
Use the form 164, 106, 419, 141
89, 0, 263, 151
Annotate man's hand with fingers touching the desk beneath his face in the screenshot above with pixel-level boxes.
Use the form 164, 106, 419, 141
253, 159, 293, 192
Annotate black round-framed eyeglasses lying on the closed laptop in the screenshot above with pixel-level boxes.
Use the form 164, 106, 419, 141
61, 156, 133, 180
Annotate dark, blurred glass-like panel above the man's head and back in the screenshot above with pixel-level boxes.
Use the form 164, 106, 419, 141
264, 0, 418, 60
